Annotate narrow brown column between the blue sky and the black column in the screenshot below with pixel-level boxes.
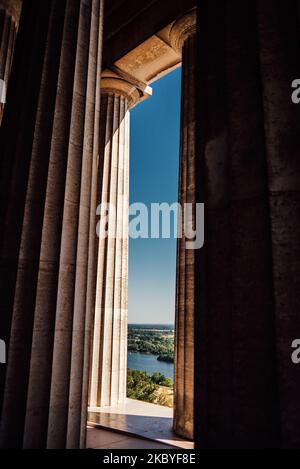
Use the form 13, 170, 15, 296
170, 10, 196, 439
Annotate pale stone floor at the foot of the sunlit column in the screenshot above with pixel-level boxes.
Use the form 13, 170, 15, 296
88, 399, 194, 449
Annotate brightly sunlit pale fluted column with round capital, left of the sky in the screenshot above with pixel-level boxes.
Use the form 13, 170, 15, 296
90, 72, 149, 408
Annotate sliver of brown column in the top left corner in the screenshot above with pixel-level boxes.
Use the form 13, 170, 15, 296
0, 0, 22, 125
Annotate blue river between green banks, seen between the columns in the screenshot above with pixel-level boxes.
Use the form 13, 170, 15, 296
128, 352, 174, 379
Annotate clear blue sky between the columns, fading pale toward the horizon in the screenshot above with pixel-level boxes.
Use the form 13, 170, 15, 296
129, 69, 181, 324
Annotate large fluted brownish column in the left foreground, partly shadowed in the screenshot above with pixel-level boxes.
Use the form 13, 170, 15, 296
0, 0, 103, 448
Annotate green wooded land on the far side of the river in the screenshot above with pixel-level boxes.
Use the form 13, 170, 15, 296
128, 325, 174, 363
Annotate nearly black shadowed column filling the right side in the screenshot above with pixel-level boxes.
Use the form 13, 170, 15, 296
195, 0, 300, 449
